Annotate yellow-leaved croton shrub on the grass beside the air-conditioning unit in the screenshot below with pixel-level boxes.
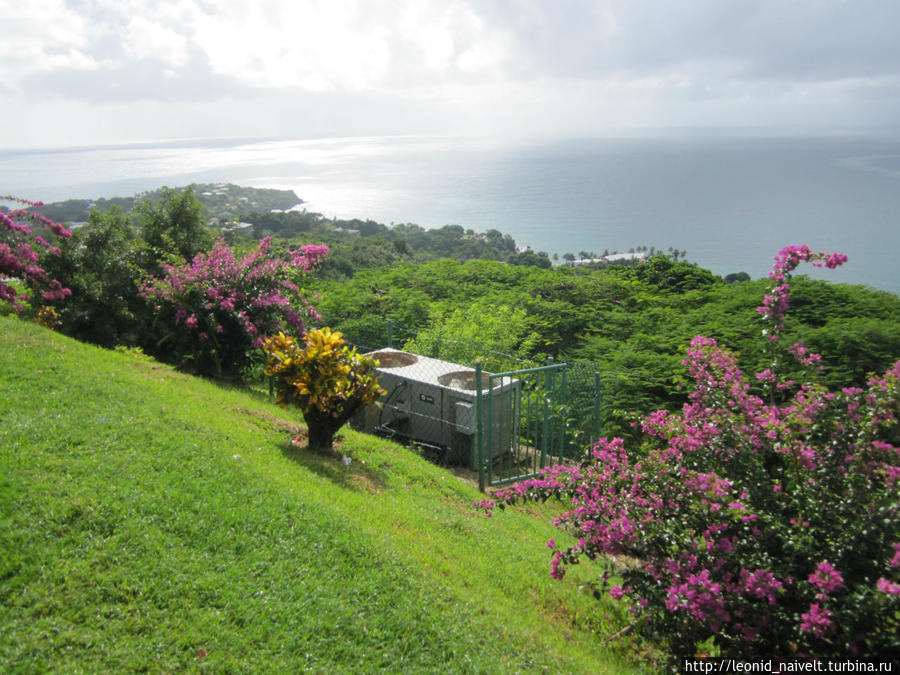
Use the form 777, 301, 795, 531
263, 328, 383, 450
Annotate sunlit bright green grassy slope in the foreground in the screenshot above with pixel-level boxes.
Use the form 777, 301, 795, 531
0, 318, 648, 673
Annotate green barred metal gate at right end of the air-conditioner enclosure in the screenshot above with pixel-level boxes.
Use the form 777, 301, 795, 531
475, 361, 568, 492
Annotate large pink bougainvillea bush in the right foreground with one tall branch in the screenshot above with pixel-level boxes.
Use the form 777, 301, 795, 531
479, 246, 900, 658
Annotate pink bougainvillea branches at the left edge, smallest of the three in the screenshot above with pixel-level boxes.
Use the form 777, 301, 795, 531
0, 195, 72, 312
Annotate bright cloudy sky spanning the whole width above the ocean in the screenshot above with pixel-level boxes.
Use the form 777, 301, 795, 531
0, 0, 900, 148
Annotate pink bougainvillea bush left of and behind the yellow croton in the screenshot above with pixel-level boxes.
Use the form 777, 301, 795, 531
140, 238, 328, 376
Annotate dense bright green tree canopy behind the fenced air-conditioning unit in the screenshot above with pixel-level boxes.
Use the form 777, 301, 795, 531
308, 257, 900, 434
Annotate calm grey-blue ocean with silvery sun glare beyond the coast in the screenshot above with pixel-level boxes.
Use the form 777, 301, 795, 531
0, 131, 900, 293
